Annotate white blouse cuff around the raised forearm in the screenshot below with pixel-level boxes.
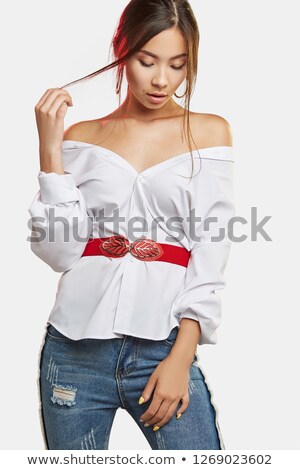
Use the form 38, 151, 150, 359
38, 171, 79, 204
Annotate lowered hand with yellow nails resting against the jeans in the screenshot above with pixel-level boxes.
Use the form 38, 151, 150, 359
140, 355, 190, 427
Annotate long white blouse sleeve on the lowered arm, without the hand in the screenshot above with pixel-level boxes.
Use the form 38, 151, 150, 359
173, 159, 235, 345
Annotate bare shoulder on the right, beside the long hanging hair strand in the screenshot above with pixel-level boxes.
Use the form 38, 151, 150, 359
195, 113, 233, 147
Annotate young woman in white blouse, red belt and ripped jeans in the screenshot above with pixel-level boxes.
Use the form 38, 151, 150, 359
29, 0, 234, 449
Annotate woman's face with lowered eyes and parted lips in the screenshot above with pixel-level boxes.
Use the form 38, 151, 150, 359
126, 27, 187, 109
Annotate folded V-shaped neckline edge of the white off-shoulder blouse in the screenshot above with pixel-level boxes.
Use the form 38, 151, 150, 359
63, 139, 233, 177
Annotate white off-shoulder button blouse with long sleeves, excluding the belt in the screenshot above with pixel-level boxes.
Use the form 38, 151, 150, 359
28, 140, 235, 345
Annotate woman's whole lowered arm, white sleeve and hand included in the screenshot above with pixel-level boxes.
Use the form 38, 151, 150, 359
140, 146, 235, 430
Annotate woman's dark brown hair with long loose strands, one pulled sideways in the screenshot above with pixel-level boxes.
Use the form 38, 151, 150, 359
61, 0, 201, 180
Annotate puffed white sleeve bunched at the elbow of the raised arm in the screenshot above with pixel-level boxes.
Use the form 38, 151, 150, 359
28, 171, 92, 272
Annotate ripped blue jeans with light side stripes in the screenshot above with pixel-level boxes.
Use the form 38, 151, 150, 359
38, 325, 225, 450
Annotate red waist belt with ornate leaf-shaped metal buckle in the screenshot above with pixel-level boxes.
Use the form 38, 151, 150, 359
82, 235, 191, 267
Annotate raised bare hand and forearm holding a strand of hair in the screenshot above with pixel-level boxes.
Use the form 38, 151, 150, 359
34, 88, 73, 172
